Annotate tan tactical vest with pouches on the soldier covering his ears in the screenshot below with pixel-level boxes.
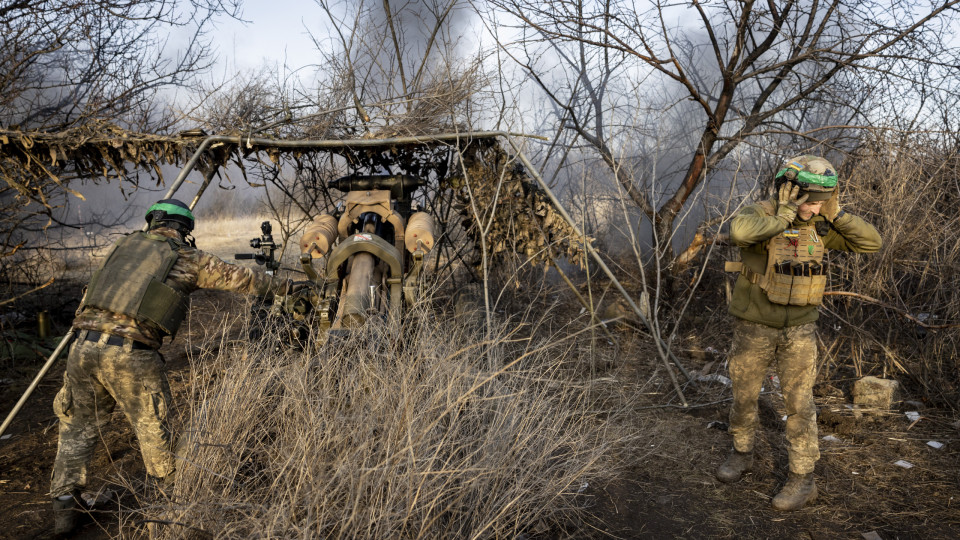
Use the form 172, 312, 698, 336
725, 201, 827, 306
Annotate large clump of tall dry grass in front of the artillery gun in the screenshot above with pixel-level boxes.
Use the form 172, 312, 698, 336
142, 298, 630, 538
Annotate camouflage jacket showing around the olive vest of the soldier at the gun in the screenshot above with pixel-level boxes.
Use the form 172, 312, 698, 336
73, 227, 290, 348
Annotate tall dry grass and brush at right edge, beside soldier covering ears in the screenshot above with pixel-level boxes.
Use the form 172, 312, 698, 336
821, 136, 960, 409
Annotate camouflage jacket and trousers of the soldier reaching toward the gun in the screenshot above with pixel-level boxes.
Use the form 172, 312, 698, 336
50, 228, 290, 497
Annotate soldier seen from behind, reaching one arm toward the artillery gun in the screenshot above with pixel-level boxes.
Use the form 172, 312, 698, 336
50, 199, 290, 535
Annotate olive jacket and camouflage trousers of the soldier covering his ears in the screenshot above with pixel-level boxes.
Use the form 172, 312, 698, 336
729, 201, 881, 475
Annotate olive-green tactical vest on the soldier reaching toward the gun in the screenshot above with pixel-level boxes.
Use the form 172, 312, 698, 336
80, 232, 187, 334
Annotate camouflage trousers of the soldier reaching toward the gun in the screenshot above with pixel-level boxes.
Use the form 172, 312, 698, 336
50, 331, 175, 497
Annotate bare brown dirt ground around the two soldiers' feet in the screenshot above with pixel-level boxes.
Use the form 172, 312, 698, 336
0, 291, 960, 540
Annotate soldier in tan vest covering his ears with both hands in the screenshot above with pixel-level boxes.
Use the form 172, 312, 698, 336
717, 155, 881, 511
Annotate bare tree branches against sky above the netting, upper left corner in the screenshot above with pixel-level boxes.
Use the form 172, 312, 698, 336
0, 0, 238, 132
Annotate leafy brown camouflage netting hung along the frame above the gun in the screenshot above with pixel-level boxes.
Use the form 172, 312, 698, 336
0, 123, 582, 272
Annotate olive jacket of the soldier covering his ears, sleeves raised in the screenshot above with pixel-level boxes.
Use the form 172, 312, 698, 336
728, 201, 882, 328
